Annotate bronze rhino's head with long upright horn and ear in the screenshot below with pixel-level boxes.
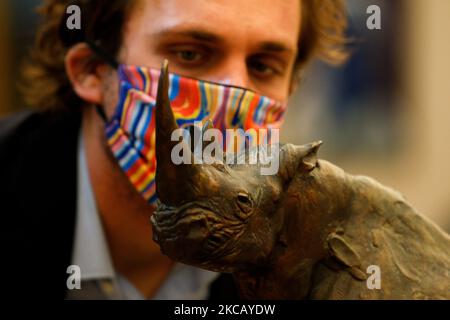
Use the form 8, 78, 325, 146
151, 63, 321, 272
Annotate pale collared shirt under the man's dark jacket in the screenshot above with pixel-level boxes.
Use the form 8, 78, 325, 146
67, 133, 219, 300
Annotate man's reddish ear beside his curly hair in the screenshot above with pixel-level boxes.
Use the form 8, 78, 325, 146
64, 43, 106, 104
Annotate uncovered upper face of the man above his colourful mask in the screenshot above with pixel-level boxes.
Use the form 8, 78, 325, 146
101, 0, 300, 114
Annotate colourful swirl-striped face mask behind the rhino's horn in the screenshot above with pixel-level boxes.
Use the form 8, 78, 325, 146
106, 65, 286, 203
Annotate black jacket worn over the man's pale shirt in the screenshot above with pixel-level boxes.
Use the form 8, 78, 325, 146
0, 111, 237, 300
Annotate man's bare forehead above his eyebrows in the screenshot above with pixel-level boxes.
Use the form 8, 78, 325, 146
131, 0, 300, 50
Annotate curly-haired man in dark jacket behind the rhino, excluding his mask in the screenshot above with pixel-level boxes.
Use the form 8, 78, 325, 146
0, 0, 345, 299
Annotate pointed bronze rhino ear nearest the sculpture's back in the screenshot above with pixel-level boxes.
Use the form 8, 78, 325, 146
279, 141, 322, 180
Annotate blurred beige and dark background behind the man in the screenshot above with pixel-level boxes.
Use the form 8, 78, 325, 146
0, 0, 450, 231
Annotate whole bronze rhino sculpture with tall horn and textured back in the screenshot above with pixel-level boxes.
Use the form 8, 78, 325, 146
151, 63, 450, 299
